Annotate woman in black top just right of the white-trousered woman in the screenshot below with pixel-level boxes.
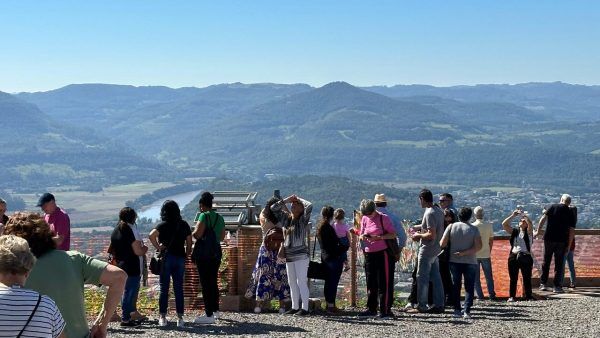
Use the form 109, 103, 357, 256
317, 206, 348, 313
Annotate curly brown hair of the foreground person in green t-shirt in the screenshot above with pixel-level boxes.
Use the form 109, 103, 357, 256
4, 212, 56, 258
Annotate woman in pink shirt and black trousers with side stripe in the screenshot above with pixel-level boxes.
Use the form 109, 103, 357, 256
354, 200, 396, 318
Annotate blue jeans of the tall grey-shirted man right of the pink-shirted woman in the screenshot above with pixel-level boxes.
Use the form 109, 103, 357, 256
417, 251, 444, 309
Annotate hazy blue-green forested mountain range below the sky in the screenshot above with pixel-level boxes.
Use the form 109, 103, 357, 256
0, 82, 600, 193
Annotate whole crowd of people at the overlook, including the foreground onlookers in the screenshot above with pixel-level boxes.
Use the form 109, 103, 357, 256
0, 189, 577, 337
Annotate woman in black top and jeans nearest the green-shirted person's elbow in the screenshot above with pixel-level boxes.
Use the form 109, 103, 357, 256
110, 207, 148, 326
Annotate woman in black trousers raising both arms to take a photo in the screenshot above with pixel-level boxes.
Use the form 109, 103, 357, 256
502, 209, 533, 302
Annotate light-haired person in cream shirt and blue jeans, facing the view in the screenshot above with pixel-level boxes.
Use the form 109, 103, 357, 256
472, 206, 496, 300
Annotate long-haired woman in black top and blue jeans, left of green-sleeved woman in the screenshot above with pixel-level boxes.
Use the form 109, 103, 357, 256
148, 200, 192, 327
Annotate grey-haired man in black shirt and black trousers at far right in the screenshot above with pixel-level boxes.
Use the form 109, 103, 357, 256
534, 194, 575, 293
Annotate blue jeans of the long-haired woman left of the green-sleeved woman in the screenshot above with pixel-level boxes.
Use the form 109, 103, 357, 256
158, 253, 185, 315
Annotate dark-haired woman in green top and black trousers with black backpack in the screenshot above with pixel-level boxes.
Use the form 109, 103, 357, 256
192, 192, 225, 324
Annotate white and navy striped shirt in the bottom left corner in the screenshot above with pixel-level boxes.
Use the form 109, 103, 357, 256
0, 286, 65, 338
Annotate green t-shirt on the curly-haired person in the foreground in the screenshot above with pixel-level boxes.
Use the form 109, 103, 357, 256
25, 250, 108, 338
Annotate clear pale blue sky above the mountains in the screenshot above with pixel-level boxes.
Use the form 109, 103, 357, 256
0, 0, 600, 92
